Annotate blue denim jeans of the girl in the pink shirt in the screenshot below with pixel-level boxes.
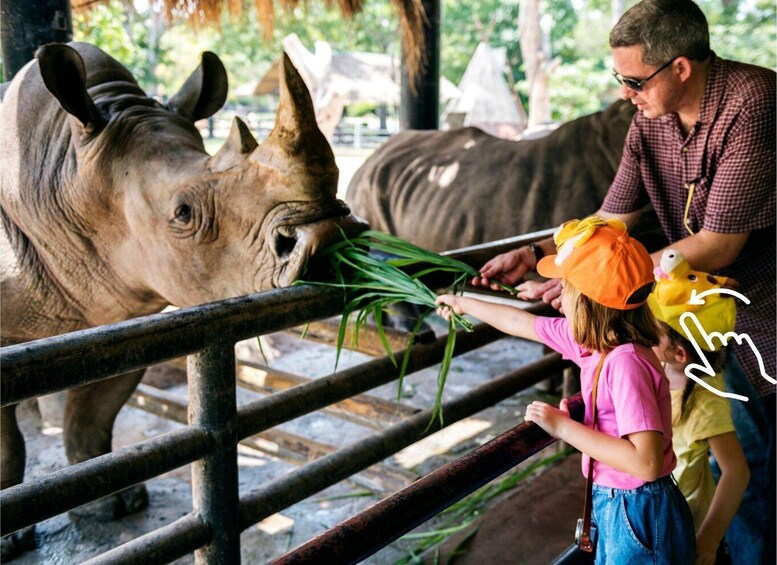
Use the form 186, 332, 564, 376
592, 475, 696, 565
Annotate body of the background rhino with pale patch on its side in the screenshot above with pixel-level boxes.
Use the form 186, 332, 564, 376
345, 101, 634, 251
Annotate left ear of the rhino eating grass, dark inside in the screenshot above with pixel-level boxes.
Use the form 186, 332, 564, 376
35, 43, 105, 131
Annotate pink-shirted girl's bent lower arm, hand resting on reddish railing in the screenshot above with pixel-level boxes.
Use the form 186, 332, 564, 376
525, 399, 664, 482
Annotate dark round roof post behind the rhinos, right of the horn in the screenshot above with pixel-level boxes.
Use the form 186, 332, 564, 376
399, 0, 441, 130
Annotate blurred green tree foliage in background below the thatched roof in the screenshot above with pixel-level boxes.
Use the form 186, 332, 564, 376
74, 0, 777, 120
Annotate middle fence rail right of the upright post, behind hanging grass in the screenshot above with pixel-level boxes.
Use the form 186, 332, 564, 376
237, 324, 504, 439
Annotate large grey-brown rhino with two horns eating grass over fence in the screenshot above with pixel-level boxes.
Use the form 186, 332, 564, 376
0, 43, 363, 557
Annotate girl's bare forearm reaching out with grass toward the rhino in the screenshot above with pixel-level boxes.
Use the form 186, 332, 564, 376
437, 294, 539, 341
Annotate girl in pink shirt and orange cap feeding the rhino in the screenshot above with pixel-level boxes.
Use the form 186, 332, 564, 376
437, 217, 695, 565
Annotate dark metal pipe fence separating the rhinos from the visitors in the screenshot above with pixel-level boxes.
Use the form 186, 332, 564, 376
0, 228, 565, 563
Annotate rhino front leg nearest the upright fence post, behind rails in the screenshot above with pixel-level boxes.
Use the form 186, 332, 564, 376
63, 369, 148, 520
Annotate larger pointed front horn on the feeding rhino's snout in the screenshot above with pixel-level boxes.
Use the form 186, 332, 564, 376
251, 53, 338, 196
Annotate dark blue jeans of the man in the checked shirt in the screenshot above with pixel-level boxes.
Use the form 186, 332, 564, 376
712, 350, 775, 565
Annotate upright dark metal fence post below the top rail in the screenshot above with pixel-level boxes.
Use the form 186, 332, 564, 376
188, 343, 240, 565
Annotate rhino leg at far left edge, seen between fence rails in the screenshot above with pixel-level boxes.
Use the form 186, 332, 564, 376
0, 404, 35, 561
